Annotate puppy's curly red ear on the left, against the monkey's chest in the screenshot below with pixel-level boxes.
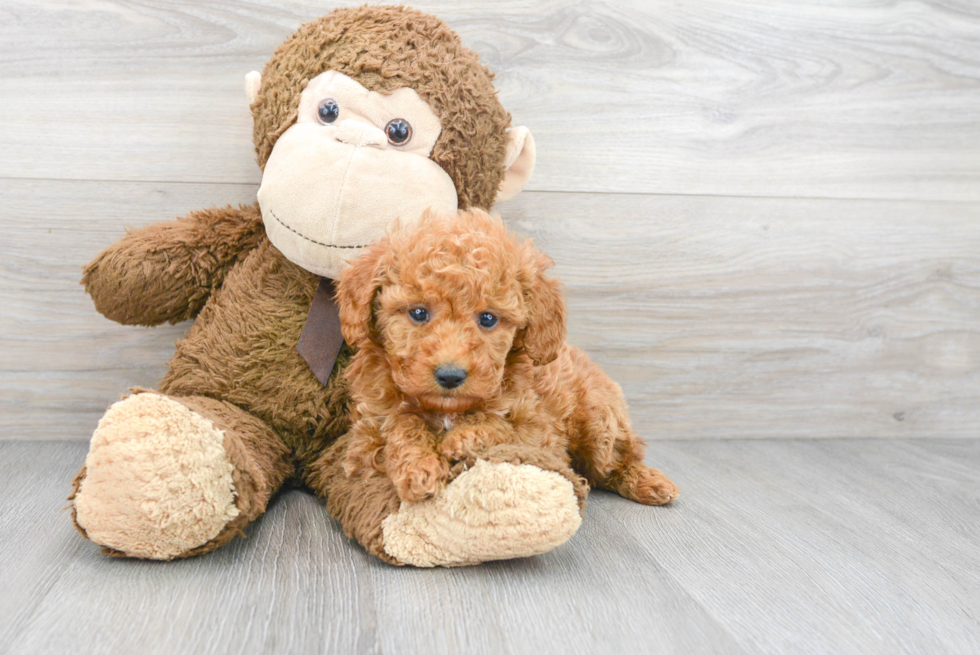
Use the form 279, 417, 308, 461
337, 245, 387, 348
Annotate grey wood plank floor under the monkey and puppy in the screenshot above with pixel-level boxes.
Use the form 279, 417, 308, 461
0, 440, 980, 655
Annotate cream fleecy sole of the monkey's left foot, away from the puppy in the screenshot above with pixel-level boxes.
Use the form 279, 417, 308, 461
72, 393, 239, 560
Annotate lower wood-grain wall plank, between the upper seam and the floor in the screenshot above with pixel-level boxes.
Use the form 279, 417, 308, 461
0, 180, 980, 439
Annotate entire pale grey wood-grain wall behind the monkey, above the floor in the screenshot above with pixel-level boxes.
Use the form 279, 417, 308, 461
0, 0, 980, 440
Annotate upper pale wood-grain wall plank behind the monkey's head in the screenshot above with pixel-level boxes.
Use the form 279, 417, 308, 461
0, 0, 980, 200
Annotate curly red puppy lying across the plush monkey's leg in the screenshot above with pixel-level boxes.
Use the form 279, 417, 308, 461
337, 210, 678, 505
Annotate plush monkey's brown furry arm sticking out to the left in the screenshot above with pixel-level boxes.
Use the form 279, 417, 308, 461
82, 205, 265, 325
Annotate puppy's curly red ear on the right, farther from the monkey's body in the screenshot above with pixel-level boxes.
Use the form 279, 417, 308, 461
516, 243, 565, 366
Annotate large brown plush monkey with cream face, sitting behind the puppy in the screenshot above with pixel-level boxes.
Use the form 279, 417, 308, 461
72, 7, 580, 565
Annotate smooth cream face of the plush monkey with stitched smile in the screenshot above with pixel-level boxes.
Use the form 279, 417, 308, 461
258, 72, 458, 278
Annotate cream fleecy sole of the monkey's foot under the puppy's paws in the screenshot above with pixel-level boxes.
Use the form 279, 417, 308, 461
382, 460, 582, 567
